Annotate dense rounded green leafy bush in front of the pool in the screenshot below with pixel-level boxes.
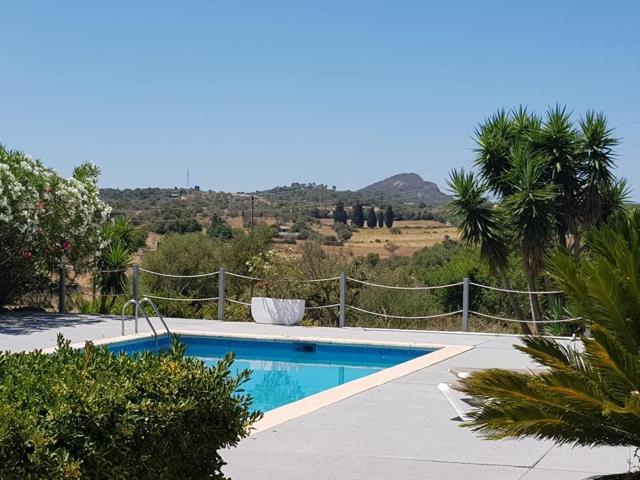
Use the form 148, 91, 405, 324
0, 337, 259, 480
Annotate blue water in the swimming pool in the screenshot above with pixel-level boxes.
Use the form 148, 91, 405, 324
109, 335, 433, 411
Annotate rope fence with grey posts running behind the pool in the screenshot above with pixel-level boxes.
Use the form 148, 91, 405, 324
62, 265, 582, 331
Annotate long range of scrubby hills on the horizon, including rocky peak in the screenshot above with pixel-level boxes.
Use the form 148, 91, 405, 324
100, 173, 449, 234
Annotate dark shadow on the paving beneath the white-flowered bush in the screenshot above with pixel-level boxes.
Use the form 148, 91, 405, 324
0, 312, 117, 335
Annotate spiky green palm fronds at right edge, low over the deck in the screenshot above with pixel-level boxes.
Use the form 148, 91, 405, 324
461, 212, 640, 447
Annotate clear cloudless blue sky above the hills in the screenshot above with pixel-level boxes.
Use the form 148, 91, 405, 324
0, 0, 640, 200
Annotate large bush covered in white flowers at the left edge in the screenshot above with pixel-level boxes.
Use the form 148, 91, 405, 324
0, 145, 111, 269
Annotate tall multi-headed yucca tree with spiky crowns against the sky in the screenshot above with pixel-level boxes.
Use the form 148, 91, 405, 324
450, 106, 626, 331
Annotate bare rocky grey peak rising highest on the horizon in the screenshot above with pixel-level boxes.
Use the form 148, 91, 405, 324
358, 173, 450, 205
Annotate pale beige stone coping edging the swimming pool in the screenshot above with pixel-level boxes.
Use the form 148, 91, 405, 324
50, 329, 475, 435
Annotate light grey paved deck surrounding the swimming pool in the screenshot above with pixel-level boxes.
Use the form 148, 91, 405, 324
0, 314, 630, 480
